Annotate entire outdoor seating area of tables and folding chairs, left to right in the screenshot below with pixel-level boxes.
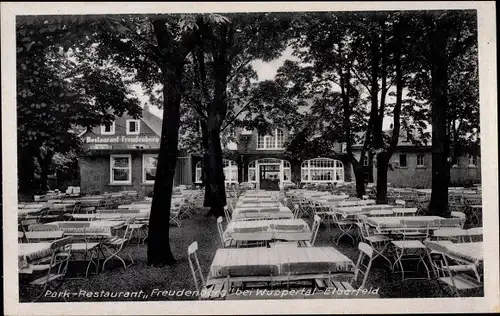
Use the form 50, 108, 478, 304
18, 181, 483, 301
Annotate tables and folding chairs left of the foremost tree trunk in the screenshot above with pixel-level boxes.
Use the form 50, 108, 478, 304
18, 188, 202, 301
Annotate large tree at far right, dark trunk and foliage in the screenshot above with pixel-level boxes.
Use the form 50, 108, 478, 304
406, 10, 477, 216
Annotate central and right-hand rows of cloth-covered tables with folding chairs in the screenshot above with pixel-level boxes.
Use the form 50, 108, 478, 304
188, 186, 483, 299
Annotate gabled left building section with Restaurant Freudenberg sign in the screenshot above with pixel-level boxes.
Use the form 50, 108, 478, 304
79, 106, 192, 196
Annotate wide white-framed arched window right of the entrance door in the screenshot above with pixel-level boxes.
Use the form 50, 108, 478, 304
301, 158, 344, 183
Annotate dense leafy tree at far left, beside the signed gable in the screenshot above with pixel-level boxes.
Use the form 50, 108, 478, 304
16, 15, 139, 195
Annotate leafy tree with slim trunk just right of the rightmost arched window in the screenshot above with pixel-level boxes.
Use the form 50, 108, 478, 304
274, 13, 374, 197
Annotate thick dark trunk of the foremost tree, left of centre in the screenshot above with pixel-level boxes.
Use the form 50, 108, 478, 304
148, 19, 189, 266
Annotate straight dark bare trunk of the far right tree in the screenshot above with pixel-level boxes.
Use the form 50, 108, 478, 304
429, 41, 449, 216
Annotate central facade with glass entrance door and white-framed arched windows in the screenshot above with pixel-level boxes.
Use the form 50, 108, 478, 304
194, 129, 345, 190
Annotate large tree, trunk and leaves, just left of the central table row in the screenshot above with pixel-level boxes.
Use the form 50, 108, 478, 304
183, 13, 290, 216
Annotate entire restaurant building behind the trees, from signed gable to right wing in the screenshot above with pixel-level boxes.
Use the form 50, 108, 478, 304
79, 106, 481, 196
